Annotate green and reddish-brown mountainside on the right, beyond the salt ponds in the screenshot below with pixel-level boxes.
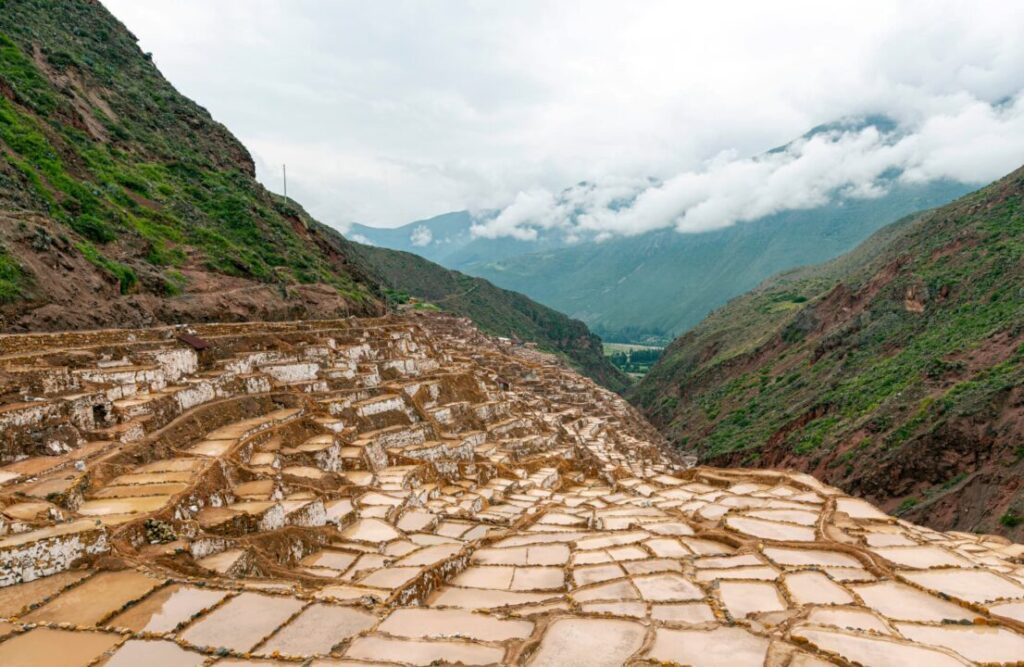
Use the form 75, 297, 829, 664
630, 169, 1024, 538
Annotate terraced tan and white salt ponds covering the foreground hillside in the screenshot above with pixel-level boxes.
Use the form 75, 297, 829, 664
0, 315, 1024, 667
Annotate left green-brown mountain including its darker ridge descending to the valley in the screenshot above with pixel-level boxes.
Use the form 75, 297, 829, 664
0, 0, 625, 389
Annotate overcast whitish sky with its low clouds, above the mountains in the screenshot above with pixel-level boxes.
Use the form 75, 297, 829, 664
104, 0, 1024, 240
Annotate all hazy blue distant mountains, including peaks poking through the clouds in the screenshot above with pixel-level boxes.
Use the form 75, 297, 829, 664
351, 126, 973, 344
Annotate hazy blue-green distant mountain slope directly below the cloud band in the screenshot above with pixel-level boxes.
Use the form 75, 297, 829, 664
461, 182, 969, 342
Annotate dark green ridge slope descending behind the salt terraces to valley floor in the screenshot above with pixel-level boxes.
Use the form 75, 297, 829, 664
358, 246, 629, 391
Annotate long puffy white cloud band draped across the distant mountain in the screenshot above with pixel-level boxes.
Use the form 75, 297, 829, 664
473, 95, 1024, 240
